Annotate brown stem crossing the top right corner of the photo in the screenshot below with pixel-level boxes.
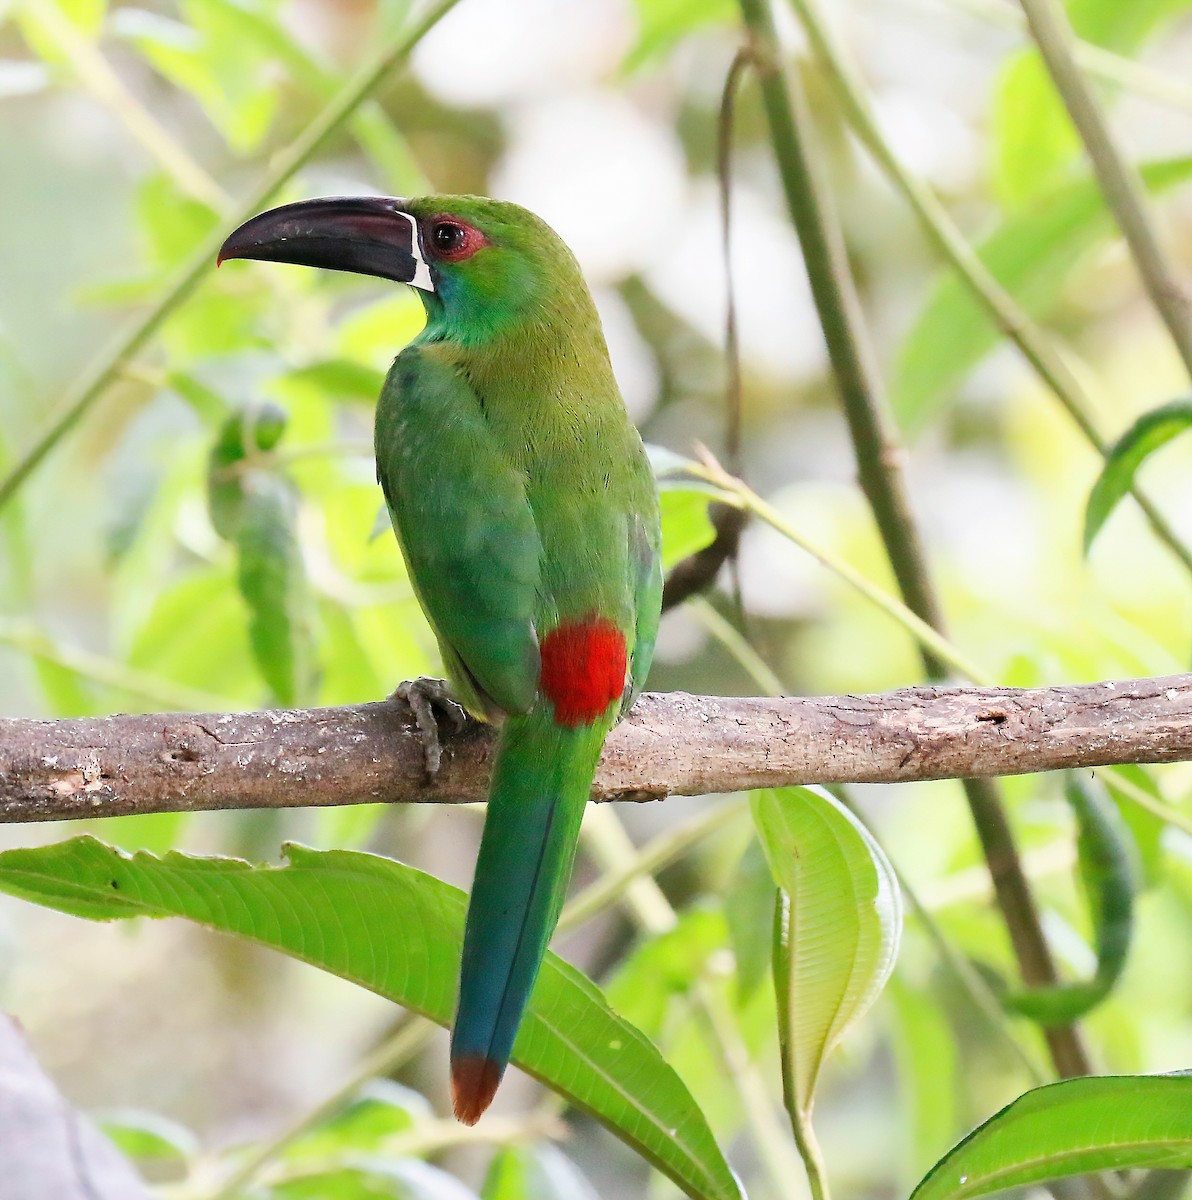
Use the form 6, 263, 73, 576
1020, 0, 1192, 376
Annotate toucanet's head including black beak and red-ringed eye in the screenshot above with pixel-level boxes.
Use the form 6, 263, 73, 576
218, 196, 591, 342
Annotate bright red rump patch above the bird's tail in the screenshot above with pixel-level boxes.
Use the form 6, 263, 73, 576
539, 617, 627, 730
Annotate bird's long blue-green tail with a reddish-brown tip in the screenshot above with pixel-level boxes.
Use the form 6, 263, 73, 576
451, 704, 612, 1124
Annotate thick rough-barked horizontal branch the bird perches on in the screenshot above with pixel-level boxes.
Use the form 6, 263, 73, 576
0, 674, 1192, 821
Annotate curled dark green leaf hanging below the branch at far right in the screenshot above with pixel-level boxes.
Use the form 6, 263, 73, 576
1004, 772, 1134, 1026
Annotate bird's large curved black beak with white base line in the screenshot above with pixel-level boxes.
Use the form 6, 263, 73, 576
216, 196, 435, 292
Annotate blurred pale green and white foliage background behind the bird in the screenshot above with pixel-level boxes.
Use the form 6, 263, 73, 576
0, 0, 1192, 1196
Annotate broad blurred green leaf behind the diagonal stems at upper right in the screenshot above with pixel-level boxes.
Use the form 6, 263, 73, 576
891, 157, 1192, 432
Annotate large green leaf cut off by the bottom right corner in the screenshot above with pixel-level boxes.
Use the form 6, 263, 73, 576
911, 1073, 1192, 1200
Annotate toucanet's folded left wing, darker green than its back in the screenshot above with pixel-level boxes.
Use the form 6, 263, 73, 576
376, 346, 543, 713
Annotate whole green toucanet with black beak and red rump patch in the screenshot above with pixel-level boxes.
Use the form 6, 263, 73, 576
213, 196, 661, 1124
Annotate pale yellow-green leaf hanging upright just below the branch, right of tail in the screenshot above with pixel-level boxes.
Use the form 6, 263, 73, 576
751, 787, 902, 1114
